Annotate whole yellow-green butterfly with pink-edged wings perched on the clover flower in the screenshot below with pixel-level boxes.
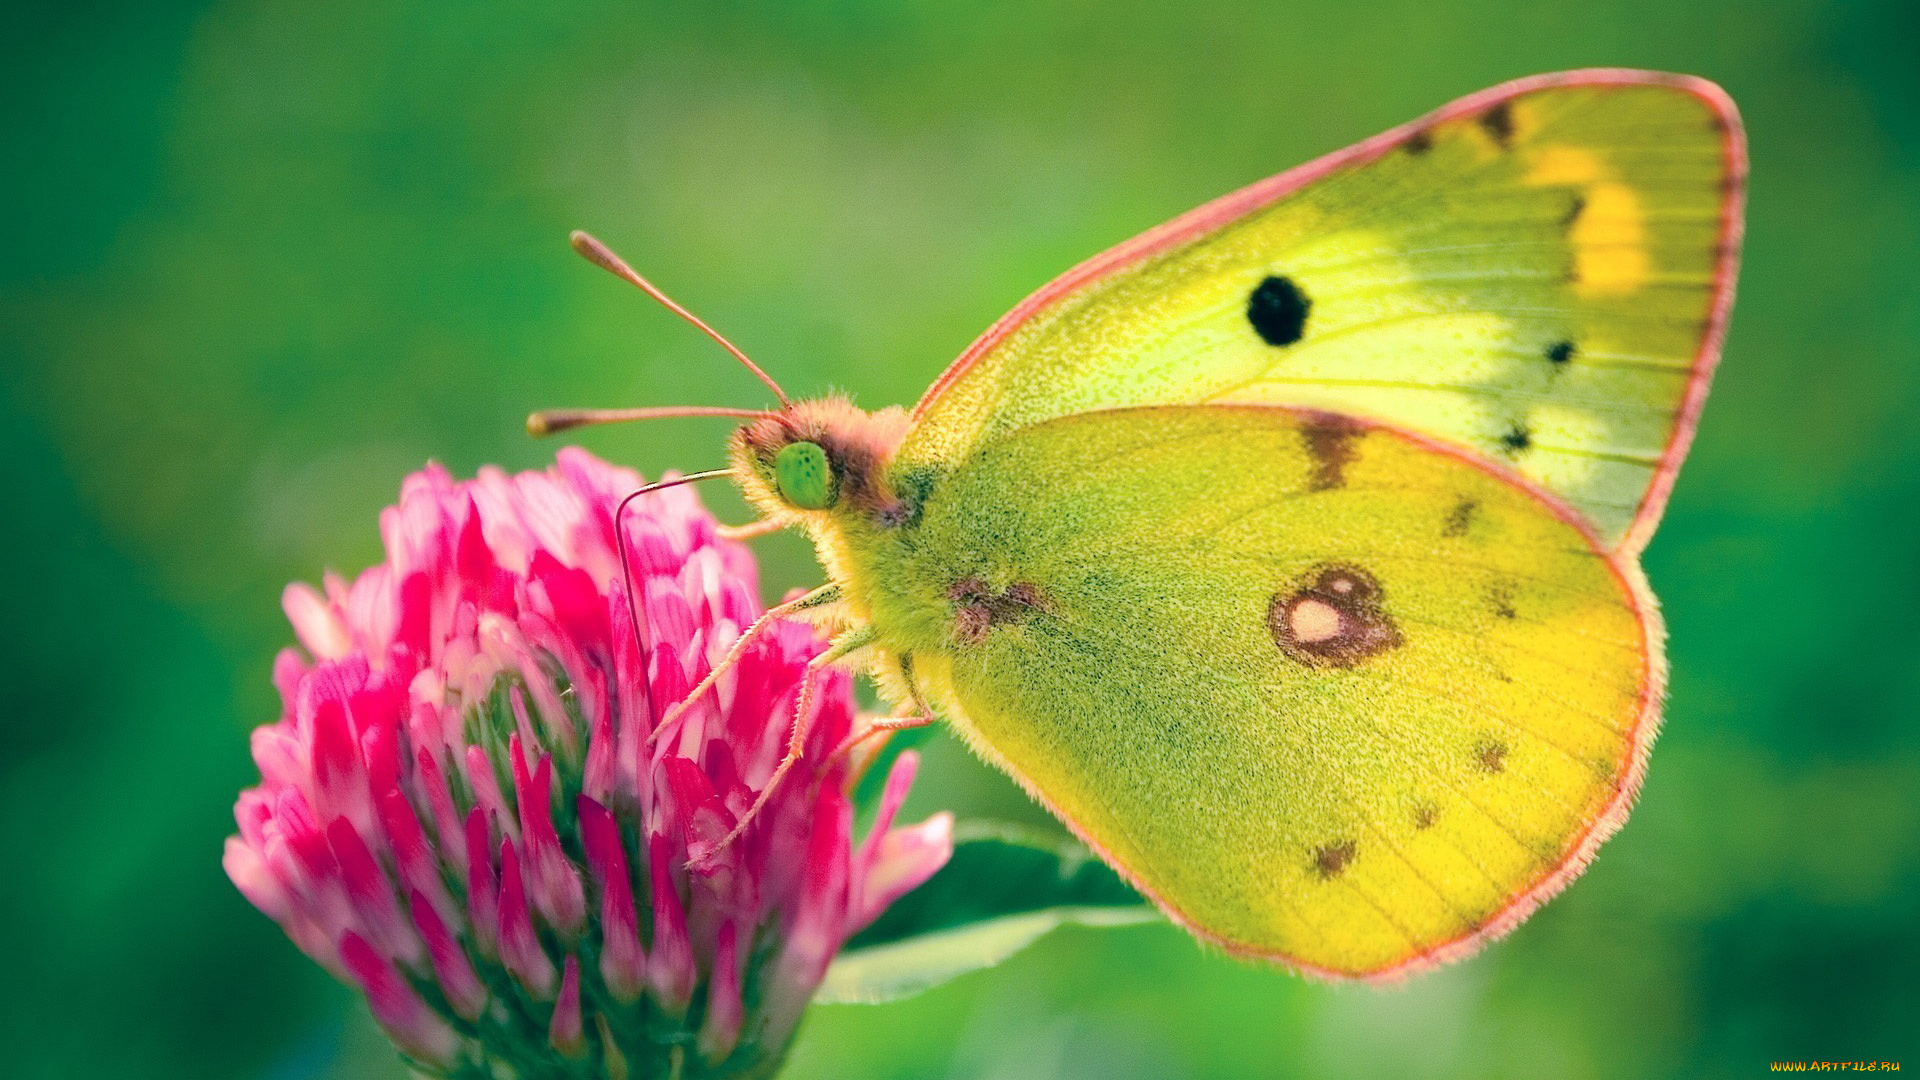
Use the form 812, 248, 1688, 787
530, 69, 1745, 978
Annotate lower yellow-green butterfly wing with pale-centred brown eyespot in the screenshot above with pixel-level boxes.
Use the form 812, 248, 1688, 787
890, 407, 1663, 976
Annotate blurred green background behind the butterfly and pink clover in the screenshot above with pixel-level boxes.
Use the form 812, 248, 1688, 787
0, 0, 1920, 1080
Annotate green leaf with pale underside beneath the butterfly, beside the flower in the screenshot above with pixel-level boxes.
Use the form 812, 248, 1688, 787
814, 824, 1160, 1003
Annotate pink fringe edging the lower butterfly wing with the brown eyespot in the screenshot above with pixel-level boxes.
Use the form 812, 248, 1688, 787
940, 404, 1667, 986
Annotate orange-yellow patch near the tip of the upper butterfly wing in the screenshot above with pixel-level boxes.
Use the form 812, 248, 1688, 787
1523, 146, 1653, 298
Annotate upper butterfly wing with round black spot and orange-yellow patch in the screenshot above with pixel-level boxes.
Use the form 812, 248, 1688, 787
897, 71, 1745, 550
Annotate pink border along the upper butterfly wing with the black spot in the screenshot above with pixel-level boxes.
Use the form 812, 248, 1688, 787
912, 67, 1747, 553
